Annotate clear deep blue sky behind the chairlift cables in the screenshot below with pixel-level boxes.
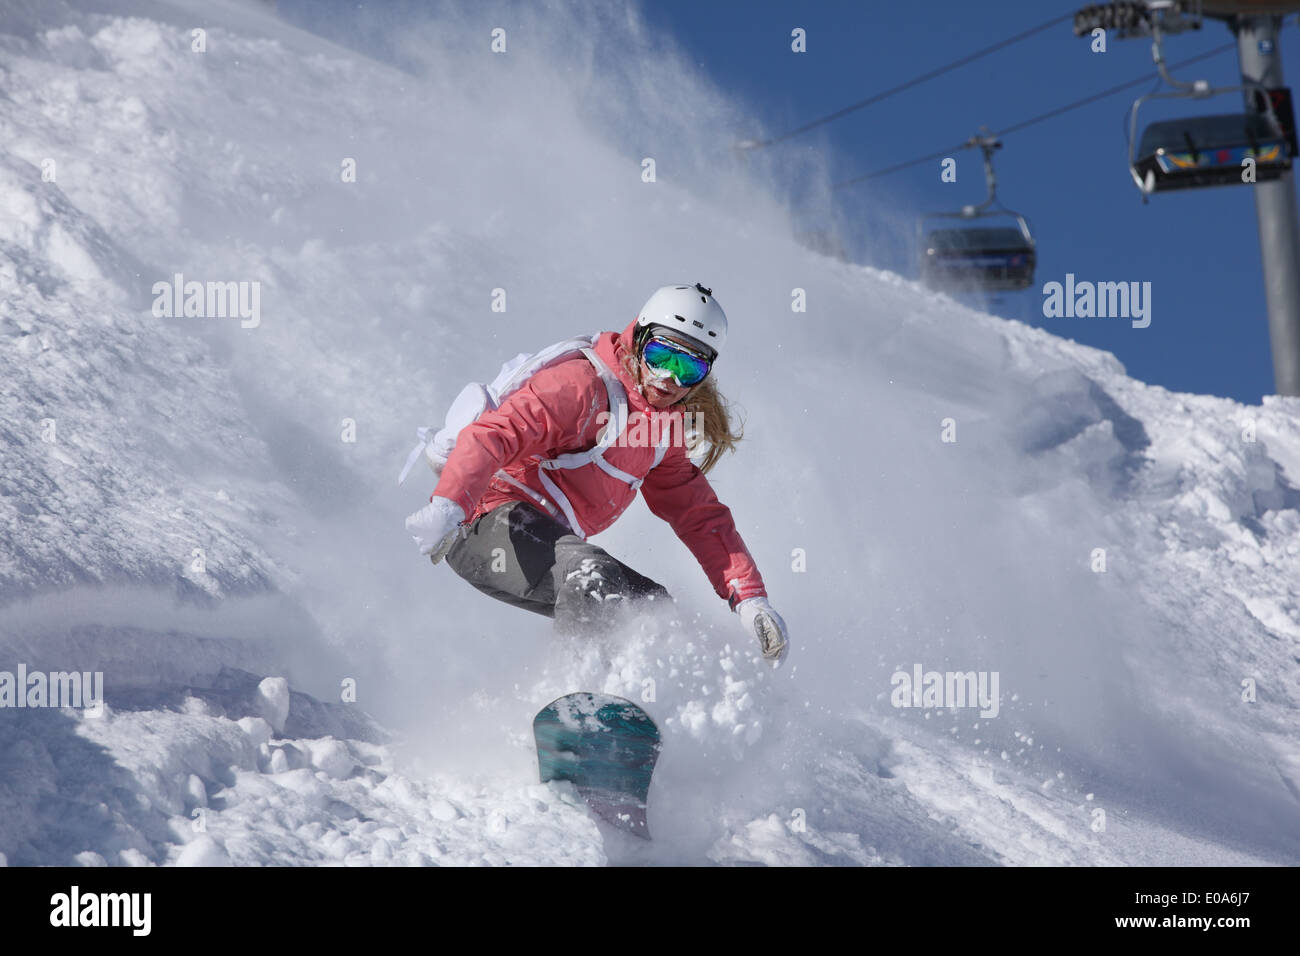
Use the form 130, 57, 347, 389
281, 0, 1300, 403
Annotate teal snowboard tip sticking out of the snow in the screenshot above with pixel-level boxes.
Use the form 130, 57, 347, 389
533, 693, 662, 839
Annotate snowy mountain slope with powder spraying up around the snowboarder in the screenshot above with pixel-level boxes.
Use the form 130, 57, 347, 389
0, 0, 1300, 865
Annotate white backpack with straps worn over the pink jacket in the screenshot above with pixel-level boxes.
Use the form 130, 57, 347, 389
398, 333, 668, 538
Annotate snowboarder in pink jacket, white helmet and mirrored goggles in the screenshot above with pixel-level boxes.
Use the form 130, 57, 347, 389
406, 284, 789, 662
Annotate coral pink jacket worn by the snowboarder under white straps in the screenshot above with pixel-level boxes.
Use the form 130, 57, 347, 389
434, 323, 767, 607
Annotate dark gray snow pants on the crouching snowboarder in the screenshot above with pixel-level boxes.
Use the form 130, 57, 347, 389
447, 501, 672, 636
